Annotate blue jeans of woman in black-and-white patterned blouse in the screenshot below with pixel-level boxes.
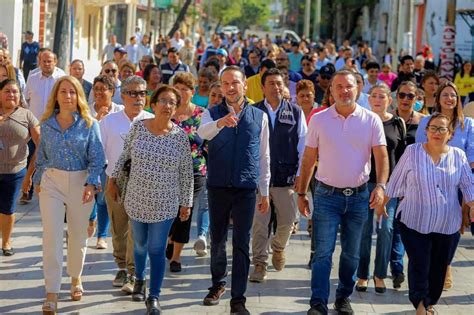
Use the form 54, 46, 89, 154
130, 218, 174, 298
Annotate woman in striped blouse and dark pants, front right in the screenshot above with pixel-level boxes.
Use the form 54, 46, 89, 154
377, 113, 474, 315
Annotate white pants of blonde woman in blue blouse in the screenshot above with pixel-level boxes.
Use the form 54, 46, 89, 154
39, 169, 94, 293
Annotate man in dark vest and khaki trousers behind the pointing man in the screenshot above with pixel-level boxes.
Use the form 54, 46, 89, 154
249, 68, 307, 282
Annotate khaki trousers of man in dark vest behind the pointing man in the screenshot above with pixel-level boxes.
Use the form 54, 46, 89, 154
252, 187, 298, 266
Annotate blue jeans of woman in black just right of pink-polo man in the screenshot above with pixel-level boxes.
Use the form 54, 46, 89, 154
357, 183, 397, 279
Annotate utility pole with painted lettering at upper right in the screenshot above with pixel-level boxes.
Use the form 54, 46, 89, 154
440, 0, 456, 81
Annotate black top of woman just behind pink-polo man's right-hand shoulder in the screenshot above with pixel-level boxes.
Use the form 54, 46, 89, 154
369, 115, 406, 183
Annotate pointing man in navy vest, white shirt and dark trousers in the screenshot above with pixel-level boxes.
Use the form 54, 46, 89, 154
198, 66, 270, 315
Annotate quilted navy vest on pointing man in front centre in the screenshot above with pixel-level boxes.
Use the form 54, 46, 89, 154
207, 101, 265, 189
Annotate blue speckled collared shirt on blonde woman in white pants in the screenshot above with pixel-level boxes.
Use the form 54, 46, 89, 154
33, 112, 105, 186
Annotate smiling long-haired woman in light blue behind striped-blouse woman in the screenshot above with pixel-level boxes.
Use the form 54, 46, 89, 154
416, 81, 474, 290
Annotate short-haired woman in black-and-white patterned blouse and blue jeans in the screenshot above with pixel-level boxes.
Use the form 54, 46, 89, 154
108, 85, 193, 314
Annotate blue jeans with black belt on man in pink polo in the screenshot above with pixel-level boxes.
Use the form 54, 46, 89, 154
310, 183, 369, 305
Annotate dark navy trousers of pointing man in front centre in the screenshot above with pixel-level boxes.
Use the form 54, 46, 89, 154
208, 187, 257, 304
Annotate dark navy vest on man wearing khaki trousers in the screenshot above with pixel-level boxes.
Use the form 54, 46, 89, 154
255, 100, 301, 187
